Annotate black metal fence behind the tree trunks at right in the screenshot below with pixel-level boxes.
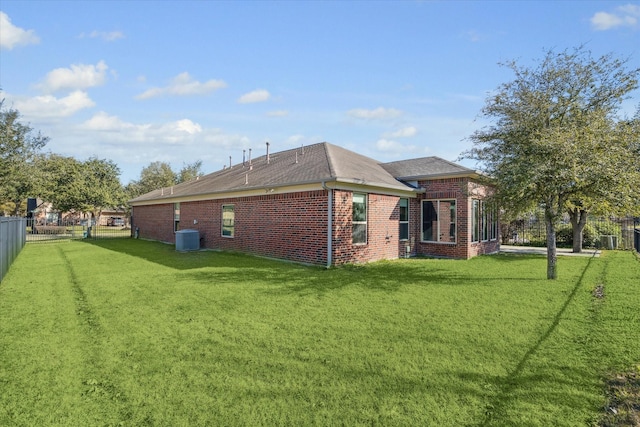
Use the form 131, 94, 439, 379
500, 211, 640, 251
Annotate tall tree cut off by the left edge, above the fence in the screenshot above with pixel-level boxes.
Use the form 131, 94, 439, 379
0, 101, 49, 215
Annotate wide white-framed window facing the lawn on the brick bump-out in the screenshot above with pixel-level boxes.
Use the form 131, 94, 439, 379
421, 199, 457, 243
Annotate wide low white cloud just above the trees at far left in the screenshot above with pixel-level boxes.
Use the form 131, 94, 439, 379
13, 90, 95, 118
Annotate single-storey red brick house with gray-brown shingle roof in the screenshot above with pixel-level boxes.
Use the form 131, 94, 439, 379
130, 143, 499, 266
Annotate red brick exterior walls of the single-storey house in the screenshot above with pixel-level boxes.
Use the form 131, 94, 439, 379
133, 178, 499, 265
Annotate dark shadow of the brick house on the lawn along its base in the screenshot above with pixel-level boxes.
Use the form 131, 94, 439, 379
84, 239, 544, 295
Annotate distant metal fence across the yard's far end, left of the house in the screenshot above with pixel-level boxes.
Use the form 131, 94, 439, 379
25, 219, 131, 243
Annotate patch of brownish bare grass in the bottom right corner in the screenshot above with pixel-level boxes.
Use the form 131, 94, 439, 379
600, 365, 640, 427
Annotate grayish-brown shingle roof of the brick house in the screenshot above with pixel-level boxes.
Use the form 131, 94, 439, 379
130, 142, 474, 205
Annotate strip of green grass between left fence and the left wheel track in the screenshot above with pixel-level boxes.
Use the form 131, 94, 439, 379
0, 245, 91, 426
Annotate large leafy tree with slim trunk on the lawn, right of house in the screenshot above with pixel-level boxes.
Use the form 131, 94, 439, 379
463, 47, 640, 279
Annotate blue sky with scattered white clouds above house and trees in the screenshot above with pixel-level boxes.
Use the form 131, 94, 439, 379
0, 0, 640, 184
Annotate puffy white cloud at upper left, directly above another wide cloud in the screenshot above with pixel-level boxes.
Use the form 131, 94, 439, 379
37, 61, 109, 92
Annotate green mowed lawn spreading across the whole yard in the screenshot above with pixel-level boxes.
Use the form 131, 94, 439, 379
0, 239, 640, 426
